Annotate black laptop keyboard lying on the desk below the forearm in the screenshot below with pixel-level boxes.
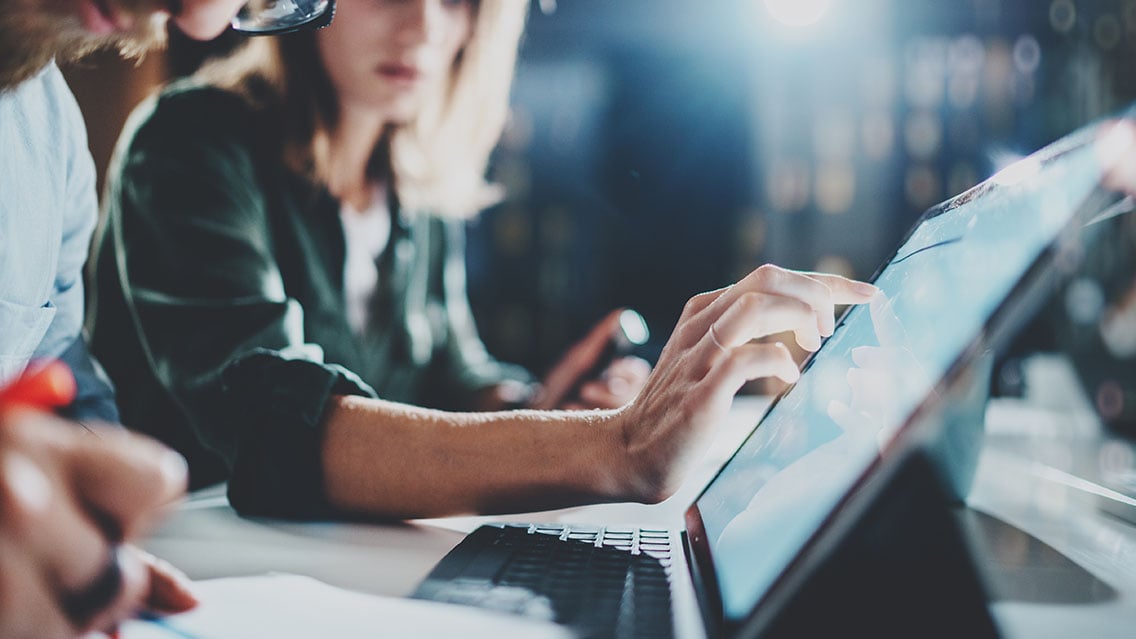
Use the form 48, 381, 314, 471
414, 524, 674, 638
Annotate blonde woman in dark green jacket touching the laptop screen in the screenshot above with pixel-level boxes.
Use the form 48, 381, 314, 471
92, 0, 871, 517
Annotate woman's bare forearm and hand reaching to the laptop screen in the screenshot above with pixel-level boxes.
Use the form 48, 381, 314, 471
319, 266, 878, 517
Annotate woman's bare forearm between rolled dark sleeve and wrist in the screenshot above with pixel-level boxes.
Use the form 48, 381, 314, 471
323, 397, 633, 518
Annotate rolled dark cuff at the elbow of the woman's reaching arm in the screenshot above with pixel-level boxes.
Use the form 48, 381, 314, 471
222, 349, 375, 520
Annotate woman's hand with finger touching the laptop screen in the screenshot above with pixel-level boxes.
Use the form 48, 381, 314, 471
616, 265, 878, 503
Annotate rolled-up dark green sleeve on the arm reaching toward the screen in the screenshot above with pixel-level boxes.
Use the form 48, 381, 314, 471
108, 90, 374, 517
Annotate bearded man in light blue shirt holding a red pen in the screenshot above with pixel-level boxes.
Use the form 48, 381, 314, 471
0, 0, 329, 639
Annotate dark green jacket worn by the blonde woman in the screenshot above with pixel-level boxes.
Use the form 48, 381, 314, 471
91, 84, 531, 517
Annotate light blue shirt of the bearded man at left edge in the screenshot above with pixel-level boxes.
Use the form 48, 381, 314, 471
0, 63, 98, 383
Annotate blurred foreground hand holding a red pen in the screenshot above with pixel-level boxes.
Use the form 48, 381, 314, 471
0, 363, 195, 639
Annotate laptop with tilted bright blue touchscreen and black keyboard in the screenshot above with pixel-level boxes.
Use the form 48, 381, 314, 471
414, 111, 1130, 637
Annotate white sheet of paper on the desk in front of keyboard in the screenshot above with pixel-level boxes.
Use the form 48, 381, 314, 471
120, 574, 571, 639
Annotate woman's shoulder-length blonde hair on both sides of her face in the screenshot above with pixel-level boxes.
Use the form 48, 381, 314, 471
198, 0, 528, 217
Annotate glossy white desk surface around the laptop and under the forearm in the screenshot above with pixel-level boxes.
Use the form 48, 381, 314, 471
145, 358, 1136, 638
